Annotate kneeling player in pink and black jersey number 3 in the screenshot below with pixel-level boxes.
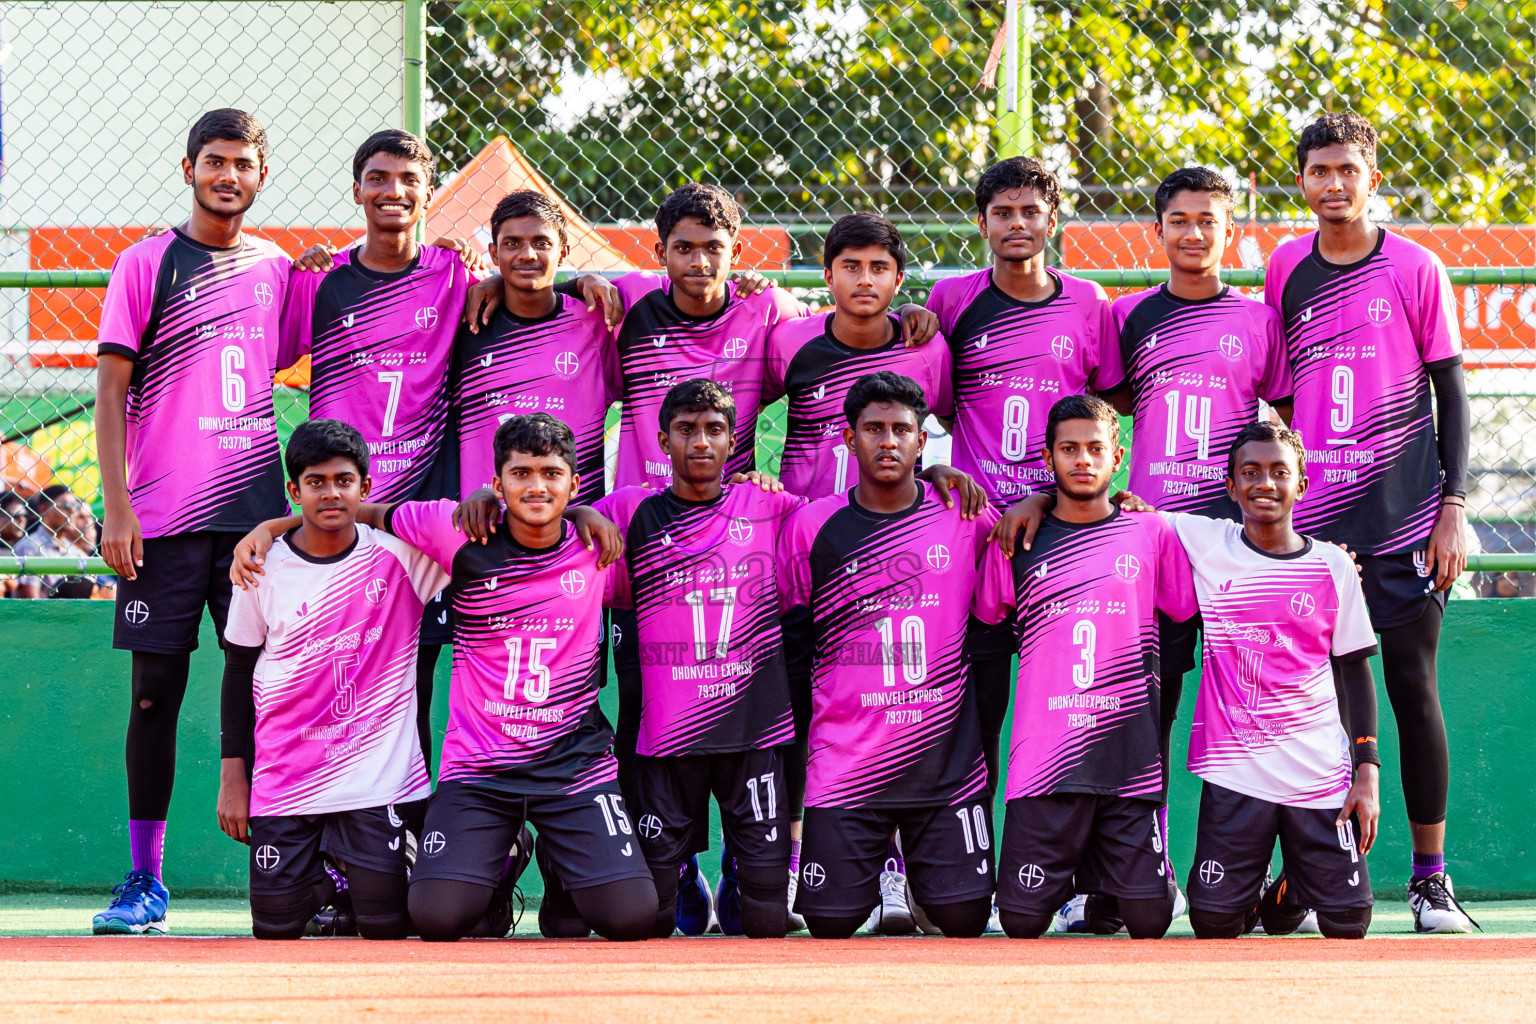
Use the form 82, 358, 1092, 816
977, 395, 1195, 938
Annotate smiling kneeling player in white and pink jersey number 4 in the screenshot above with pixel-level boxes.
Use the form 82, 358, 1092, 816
1170, 422, 1381, 938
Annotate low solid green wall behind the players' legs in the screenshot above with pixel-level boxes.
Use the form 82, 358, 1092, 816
0, 600, 1536, 897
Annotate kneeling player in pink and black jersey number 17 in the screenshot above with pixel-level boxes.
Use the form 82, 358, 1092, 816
596, 379, 803, 938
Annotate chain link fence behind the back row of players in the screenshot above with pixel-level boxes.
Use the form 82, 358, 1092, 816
0, 0, 1536, 594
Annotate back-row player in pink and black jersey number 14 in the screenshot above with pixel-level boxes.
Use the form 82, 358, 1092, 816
1104, 167, 1292, 896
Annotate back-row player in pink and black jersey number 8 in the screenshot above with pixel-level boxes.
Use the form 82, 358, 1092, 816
928, 157, 1123, 791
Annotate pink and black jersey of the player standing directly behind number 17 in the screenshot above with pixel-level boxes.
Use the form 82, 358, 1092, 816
614, 272, 806, 490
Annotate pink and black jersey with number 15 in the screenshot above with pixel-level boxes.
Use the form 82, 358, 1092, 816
387, 500, 617, 794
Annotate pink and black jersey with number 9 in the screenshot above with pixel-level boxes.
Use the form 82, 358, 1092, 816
1264, 227, 1461, 554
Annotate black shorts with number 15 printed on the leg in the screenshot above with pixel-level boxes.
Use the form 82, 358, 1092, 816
410, 781, 651, 889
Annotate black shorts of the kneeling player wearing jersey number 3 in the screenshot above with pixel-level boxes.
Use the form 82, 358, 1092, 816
997, 792, 1169, 913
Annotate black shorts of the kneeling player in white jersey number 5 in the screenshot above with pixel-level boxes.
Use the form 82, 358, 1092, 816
250, 806, 406, 897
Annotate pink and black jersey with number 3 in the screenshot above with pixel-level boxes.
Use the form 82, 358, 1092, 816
975, 508, 1197, 800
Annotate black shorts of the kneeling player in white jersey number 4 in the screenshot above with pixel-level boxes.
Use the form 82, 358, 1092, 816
1184, 783, 1372, 910
